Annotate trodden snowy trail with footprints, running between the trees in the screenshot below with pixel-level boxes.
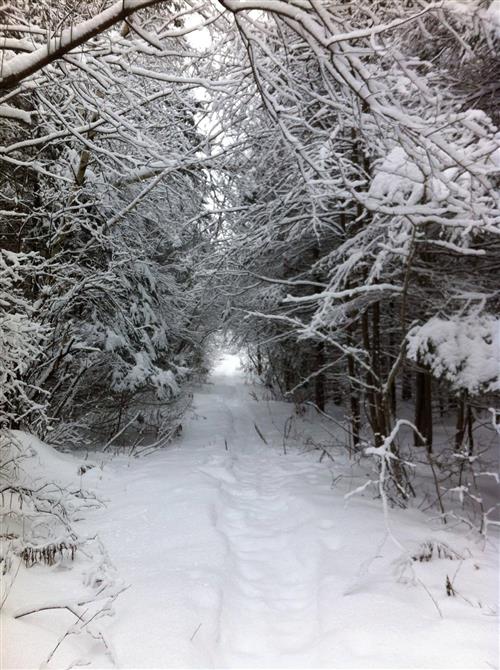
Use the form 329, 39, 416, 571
94, 358, 334, 667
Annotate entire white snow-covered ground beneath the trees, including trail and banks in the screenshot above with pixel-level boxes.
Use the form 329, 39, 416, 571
2, 356, 498, 668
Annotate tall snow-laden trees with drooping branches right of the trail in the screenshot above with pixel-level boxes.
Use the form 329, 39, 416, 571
211, 0, 500, 496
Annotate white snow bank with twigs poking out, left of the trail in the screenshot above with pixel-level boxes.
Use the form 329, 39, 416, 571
0, 431, 123, 668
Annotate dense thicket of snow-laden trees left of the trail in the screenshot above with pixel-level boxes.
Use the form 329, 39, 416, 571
2, 1, 222, 446
